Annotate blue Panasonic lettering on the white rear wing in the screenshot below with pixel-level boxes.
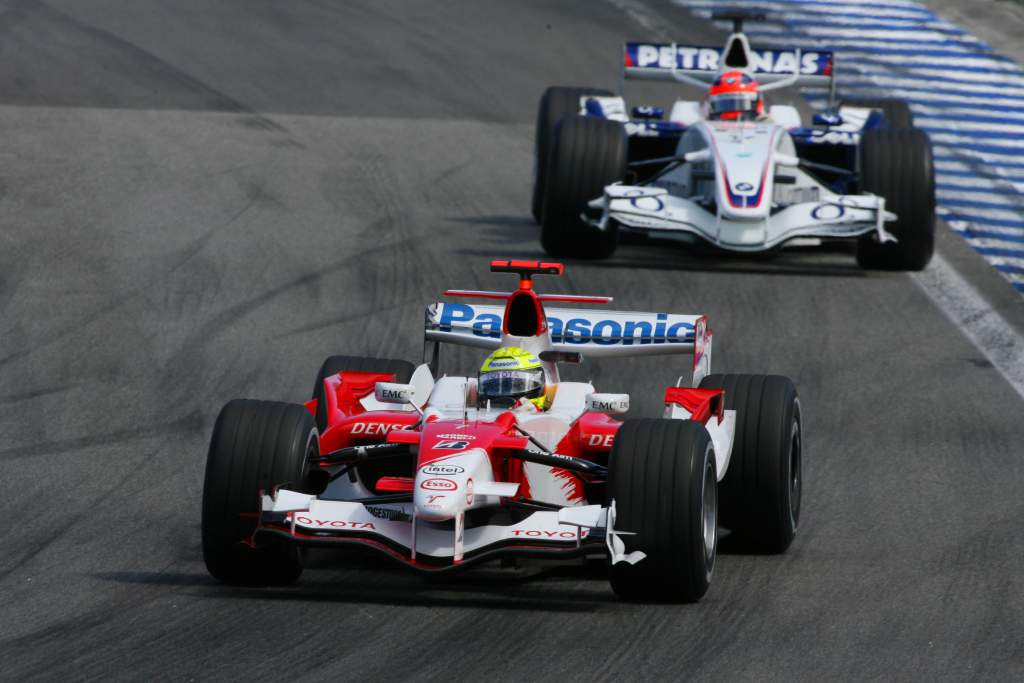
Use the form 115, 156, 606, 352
437, 305, 693, 346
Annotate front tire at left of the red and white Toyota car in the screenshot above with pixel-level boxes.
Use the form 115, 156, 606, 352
203, 399, 311, 585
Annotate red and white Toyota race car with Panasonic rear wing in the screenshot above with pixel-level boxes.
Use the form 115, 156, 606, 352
203, 261, 802, 601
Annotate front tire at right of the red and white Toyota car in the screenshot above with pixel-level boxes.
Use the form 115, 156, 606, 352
608, 419, 718, 602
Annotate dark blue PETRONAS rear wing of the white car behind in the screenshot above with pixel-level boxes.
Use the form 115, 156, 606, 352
623, 41, 835, 88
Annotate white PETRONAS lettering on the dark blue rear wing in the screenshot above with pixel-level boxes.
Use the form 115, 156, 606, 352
625, 43, 833, 76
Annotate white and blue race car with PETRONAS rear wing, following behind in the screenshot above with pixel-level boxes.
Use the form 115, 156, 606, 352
534, 13, 935, 270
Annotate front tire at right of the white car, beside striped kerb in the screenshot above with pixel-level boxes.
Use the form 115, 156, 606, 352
857, 128, 935, 270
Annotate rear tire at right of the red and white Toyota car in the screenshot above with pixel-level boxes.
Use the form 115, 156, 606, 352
700, 375, 803, 553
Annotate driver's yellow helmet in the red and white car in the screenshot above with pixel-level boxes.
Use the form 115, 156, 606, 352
476, 346, 547, 411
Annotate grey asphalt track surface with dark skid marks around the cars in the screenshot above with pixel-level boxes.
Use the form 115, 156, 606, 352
0, 0, 1024, 680
